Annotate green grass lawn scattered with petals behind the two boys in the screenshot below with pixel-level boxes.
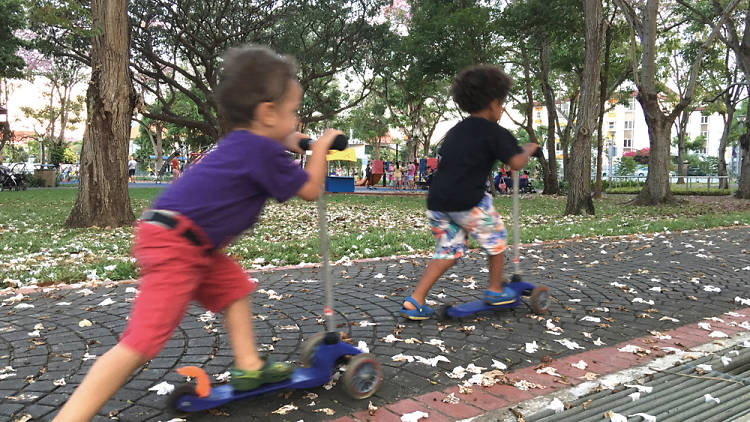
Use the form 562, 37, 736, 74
0, 188, 750, 287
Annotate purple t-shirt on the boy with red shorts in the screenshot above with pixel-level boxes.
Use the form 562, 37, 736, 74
153, 130, 308, 247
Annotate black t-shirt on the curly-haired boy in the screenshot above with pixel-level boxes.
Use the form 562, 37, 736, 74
427, 117, 523, 211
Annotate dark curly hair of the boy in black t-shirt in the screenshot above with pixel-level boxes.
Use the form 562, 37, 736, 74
451, 64, 513, 113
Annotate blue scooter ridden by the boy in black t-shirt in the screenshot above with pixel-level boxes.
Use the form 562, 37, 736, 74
438, 171, 550, 319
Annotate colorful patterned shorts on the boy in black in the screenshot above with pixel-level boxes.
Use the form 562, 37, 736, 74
427, 195, 507, 259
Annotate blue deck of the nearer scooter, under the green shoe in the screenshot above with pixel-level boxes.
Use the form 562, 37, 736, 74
175, 342, 362, 412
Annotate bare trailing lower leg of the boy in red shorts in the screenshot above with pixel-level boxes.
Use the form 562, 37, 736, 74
53, 344, 148, 422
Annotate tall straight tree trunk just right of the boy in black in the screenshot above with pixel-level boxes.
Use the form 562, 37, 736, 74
565, 0, 606, 215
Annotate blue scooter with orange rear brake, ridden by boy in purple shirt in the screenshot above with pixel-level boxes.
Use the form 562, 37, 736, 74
167, 135, 383, 412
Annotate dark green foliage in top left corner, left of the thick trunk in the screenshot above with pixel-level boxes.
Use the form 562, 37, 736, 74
0, 0, 26, 79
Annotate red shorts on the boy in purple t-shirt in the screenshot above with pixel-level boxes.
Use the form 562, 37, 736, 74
120, 215, 257, 359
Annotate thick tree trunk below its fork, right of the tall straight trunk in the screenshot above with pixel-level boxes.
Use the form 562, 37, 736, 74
634, 92, 673, 205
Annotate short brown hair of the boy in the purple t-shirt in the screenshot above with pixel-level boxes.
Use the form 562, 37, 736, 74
216, 45, 297, 127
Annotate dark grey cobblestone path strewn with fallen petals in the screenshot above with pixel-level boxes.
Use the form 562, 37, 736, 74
0, 227, 750, 421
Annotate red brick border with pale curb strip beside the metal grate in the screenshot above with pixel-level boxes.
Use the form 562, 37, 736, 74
335, 308, 750, 422
